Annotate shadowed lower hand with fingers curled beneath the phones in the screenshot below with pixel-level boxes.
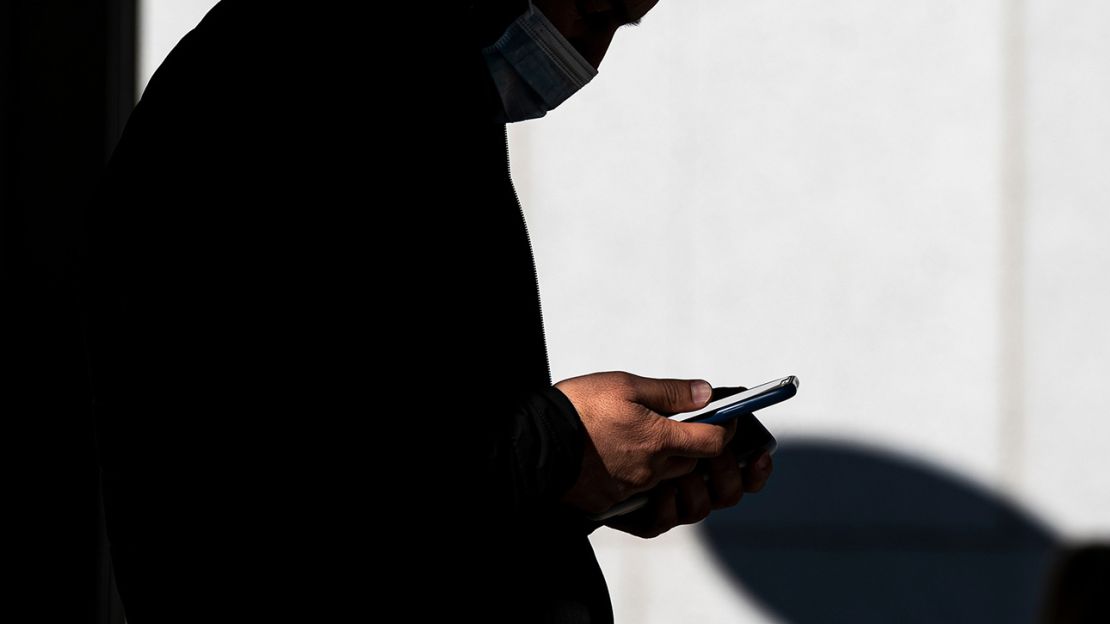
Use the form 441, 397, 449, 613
605, 441, 774, 537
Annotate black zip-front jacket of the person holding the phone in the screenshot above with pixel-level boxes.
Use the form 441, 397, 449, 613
88, 0, 612, 624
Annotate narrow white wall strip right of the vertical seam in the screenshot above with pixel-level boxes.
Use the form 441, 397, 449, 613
1021, 0, 1110, 535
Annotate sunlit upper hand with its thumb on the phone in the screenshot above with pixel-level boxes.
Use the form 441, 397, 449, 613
555, 373, 737, 514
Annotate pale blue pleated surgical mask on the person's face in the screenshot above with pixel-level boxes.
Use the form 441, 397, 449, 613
482, 3, 597, 122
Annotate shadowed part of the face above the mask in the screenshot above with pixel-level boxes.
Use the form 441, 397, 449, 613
533, 0, 659, 68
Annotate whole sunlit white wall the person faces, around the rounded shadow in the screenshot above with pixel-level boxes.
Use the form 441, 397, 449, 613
511, 0, 1110, 623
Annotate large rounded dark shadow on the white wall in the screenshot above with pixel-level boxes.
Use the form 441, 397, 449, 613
702, 439, 1059, 624
